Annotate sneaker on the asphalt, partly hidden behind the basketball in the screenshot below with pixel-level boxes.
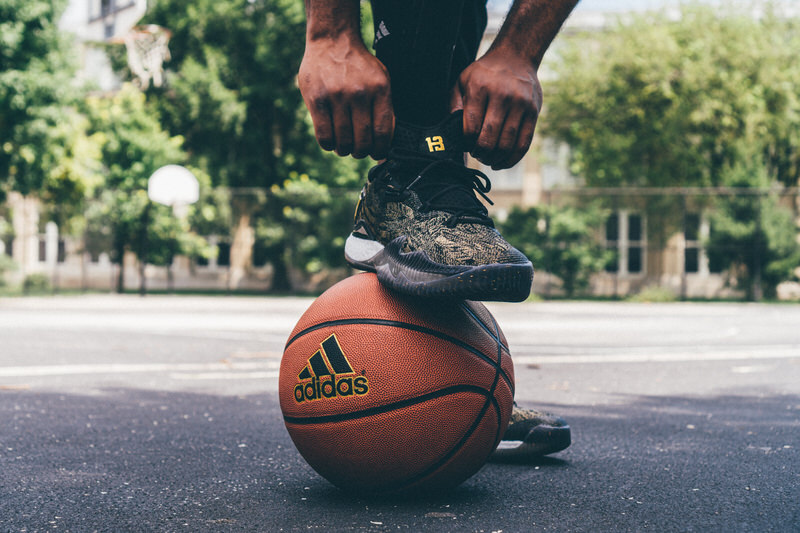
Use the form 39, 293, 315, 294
492, 402, 572, 461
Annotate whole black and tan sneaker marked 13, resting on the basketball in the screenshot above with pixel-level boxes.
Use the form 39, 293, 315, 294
344, 111, 533, 302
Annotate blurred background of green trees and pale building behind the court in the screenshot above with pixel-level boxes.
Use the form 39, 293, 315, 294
0, 0, 800, 301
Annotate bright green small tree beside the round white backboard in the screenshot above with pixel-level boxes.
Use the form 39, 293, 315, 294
86, 85, 188, 292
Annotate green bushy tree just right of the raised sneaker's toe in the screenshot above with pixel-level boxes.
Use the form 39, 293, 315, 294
500, 205, 610, 297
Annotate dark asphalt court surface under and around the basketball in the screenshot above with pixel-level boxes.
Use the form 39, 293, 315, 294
0, 296, 800, 532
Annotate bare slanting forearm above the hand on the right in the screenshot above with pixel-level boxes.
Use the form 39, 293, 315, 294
491, 0, 578, 69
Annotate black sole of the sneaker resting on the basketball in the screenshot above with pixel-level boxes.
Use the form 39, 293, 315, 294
345, 236, 533, 302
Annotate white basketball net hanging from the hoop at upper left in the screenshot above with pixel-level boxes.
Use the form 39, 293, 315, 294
124, 24, 172, 90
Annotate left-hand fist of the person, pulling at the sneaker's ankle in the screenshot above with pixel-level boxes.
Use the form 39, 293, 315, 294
298, 38, 394, 159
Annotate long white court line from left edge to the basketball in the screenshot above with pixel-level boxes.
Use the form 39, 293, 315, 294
0, 361, 280, 378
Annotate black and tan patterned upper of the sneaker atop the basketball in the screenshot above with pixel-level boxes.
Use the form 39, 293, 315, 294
353, 112, 528, 266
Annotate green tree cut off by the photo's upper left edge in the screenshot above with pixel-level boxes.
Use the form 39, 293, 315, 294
0, 0, 88, 195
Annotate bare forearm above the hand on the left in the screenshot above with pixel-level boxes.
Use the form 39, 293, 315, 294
305, 0, 362, 43
